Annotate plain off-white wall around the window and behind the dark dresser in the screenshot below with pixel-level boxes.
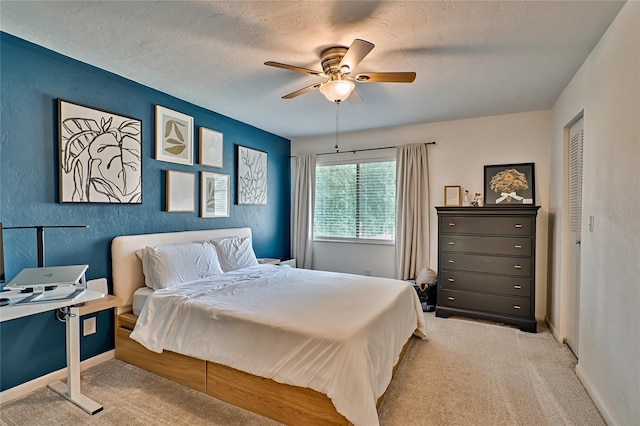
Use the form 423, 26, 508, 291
291, 110, 551, 319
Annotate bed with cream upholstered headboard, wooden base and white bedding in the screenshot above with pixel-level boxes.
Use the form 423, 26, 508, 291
112, 228, 425, 425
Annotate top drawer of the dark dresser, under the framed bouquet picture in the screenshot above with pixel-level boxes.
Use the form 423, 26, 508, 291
440, 215, 533, 236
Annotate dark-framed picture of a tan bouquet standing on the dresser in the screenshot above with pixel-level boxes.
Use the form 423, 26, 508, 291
484, 163, 536, 206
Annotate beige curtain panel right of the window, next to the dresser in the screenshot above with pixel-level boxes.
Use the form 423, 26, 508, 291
396, 143, 430, 280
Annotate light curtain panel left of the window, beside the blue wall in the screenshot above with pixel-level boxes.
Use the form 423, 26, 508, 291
292, 154, 316, 269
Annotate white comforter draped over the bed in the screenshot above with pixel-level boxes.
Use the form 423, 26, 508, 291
131, 265, 425, 425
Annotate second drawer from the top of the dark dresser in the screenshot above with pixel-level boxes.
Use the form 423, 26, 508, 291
440, 234, 531, 256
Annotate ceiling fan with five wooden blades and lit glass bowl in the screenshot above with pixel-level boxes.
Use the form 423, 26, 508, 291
264, 39, 416, 103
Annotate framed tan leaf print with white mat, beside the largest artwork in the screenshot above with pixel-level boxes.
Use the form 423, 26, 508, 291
156, 105, 193, 166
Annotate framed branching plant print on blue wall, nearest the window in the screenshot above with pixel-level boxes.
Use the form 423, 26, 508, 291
236, 145, 268, 204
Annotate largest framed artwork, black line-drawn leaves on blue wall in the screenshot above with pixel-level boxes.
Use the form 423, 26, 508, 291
58, 99, 142, 204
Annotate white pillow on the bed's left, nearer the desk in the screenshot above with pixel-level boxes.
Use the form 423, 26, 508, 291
136, 242, 223, 290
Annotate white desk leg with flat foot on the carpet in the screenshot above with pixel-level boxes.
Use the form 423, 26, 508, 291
49, 307, 102, 414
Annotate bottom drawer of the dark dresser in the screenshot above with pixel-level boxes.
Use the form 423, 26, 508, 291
438, 289, 531, 317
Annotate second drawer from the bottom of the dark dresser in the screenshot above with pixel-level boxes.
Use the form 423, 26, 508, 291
438, 270, 531, 297
